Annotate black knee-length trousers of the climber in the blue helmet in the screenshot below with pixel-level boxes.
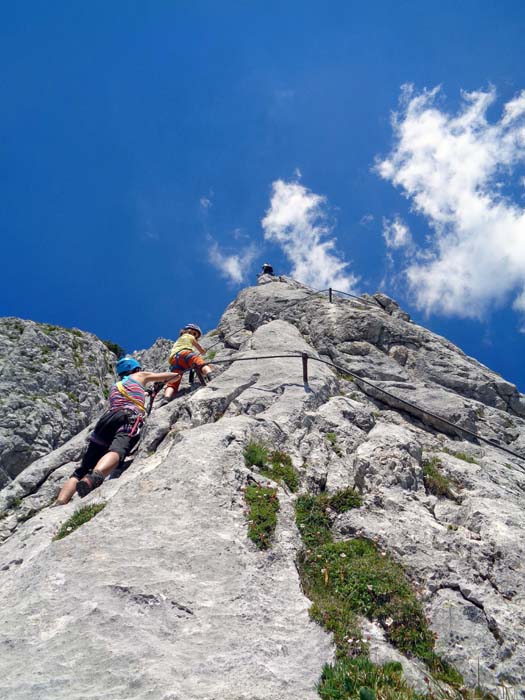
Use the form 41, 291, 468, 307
71, 409, 140, 479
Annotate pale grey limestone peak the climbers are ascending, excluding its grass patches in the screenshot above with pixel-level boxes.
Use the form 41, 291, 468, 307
0, 277, 525, 700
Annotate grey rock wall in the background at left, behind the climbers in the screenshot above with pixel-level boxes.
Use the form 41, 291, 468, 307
0, 318, 116, 488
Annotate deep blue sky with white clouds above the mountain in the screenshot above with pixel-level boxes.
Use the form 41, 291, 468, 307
0, 0, 525, 391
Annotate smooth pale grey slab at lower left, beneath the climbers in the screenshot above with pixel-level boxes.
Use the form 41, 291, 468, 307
0, 418, 332, 700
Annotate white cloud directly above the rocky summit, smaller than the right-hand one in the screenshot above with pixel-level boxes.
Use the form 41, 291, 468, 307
261, 180, 357, 292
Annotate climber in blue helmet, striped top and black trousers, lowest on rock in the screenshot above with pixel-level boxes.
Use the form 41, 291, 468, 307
56, 357, 177, 505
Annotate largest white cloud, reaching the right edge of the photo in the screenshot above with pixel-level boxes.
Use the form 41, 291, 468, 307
376, 87, 525, 318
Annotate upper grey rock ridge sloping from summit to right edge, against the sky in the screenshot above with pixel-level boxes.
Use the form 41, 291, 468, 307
228, 280, 525, 416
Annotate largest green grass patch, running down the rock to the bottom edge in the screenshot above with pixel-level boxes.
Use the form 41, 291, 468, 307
295, 489, 476, 700
